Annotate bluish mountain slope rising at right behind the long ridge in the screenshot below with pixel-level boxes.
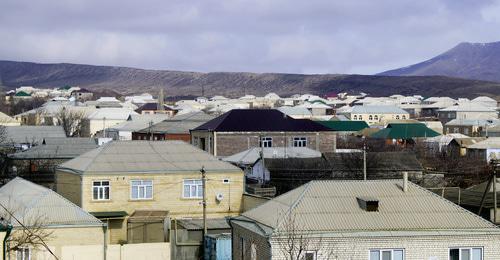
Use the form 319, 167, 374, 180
379, 42, 500, 82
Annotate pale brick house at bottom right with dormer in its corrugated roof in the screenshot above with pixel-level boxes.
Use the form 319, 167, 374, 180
230, 179, 500, 260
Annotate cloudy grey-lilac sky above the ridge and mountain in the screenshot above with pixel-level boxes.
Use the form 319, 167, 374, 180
0, 0, 500, 74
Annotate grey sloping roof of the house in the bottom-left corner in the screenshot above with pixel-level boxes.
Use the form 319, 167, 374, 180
0, 177, 103, 227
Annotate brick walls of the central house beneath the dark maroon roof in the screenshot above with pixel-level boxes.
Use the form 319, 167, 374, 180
191, 132, 336, 156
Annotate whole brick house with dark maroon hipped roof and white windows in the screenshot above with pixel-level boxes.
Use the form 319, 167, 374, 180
191, 109, 336, 157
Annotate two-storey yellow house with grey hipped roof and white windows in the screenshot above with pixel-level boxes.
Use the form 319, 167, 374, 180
56, 141, 244, 244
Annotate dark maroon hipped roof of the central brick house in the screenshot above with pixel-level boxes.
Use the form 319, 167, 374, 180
194, 109, 331, 132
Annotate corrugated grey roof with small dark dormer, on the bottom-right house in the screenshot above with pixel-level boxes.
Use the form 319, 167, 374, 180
242, 180, 500, 232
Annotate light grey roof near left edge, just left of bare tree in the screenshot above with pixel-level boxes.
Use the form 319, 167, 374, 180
5, 125, 66, 144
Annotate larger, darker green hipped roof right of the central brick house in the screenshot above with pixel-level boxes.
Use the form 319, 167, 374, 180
371, 123, 440, 139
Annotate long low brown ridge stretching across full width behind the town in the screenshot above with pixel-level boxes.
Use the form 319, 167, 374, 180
0, 61, 500, 97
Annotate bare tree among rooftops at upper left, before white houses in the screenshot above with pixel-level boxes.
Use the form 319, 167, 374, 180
55, 107, 87, 137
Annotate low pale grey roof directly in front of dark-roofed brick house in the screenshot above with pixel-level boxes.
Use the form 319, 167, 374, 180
222, 147, 321, 164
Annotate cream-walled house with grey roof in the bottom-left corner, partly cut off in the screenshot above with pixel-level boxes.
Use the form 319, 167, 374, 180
0, 177, 106, 260
